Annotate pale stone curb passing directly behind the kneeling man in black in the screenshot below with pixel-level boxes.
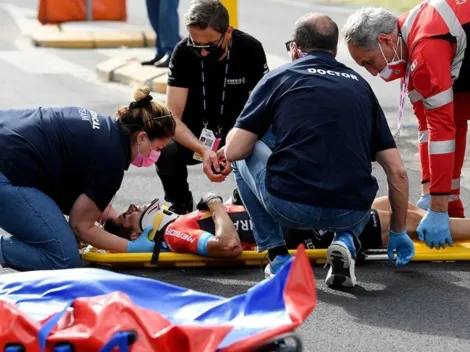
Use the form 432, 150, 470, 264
96, 54, 286, 94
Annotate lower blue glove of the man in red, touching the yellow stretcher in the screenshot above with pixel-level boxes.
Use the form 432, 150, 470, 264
416, 209, 454, 249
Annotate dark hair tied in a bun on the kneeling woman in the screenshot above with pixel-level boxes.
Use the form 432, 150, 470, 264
116, 87, 176, 140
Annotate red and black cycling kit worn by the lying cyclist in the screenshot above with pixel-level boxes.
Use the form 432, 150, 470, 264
162, 204, 382, 255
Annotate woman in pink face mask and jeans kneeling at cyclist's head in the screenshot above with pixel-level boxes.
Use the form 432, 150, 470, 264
0, 88, 176, 270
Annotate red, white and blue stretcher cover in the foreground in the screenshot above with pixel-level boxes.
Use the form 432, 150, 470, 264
0, 247, 317, 352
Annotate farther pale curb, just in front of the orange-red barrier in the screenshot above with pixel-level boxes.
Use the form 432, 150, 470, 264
31, 25, 156, 49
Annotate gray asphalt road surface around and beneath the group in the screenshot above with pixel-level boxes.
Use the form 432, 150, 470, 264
0, 0, 470, 352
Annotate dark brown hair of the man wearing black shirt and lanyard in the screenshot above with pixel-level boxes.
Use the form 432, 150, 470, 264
184, 0, 229, 33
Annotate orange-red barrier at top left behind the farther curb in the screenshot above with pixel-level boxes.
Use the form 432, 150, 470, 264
38, 0, 127, 24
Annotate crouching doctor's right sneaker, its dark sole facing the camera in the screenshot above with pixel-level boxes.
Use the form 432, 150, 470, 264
325, 232, 356, 288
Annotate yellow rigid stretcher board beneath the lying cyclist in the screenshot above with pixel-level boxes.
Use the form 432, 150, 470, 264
82, 241, 470, 267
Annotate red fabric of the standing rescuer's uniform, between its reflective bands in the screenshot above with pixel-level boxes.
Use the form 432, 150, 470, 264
398, 0, 470, 194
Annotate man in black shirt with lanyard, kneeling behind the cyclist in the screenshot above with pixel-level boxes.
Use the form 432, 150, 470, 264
156, 0, 268, 214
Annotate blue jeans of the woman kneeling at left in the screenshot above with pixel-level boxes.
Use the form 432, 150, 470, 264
0, 173, 80, 271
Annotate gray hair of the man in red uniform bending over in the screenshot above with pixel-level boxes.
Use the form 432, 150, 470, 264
342, 7, 397, 51
